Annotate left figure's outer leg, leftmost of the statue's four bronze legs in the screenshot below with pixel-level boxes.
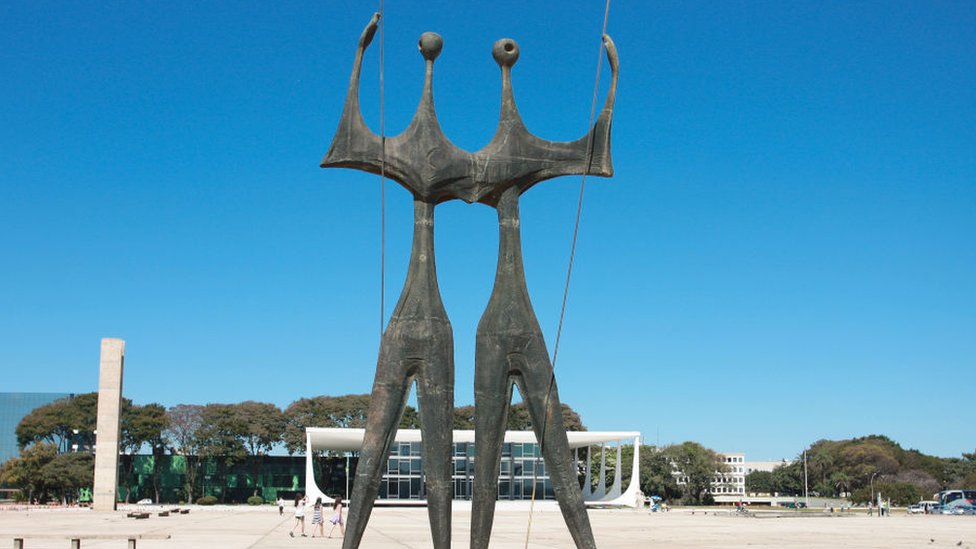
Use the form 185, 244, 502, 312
342, 342, 413, 549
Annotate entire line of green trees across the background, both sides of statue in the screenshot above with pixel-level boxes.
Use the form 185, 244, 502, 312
0, 393, 976, 505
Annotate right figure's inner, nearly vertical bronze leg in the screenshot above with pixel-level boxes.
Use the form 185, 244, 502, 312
471, 335, 512, 549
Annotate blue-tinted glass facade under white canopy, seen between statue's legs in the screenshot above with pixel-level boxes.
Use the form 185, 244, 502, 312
379, 442, 555, 500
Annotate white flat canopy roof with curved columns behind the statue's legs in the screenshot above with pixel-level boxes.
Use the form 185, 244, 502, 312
305, 427, 641, 507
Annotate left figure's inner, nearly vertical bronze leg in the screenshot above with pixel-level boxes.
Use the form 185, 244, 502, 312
417, 333, 454, 549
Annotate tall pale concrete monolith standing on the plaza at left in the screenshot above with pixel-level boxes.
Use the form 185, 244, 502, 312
92, 338, 125, 511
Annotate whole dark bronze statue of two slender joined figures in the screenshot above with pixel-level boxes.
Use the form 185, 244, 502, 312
321, 14, 618, 549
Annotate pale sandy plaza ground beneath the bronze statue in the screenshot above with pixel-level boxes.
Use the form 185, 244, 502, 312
0, 506, 976, 549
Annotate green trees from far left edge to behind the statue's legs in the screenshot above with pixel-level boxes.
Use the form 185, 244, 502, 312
0, 393, 586, 502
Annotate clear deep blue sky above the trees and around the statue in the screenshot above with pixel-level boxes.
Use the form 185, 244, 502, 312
0, 0, 976, 459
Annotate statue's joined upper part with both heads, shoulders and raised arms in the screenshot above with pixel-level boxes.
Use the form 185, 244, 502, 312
321, 14, 619, 206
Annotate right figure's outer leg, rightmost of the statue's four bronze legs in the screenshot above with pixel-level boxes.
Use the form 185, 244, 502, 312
511, 340, 596, 549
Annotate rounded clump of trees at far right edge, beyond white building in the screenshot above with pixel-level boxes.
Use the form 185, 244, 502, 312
746, 435, 976, 505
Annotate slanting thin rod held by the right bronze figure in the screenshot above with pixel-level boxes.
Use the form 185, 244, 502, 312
525, 0, 619, 549
